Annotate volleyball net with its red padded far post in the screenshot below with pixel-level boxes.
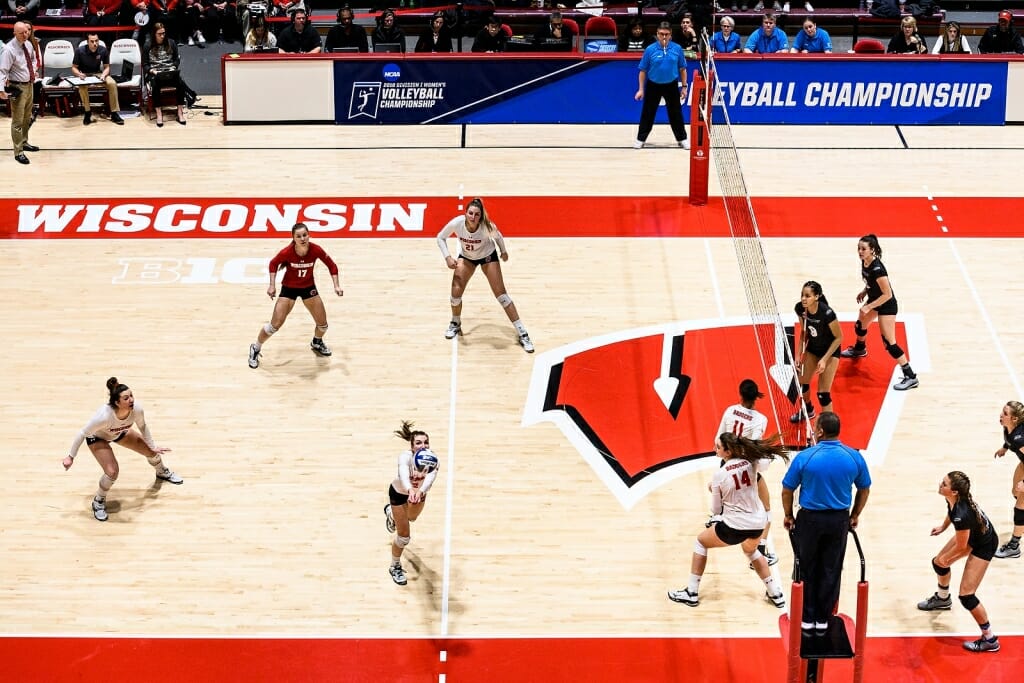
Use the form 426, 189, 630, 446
690, 41, 813, 447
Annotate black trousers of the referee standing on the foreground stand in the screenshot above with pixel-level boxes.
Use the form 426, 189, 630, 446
797, 509, 850, 624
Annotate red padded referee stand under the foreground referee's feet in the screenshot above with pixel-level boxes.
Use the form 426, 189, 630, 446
778, 528, 867, 683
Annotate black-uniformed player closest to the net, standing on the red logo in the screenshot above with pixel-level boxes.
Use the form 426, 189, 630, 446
790, 280, 843, 424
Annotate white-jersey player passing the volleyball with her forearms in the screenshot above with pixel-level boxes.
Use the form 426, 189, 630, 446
384, 421, 438, 586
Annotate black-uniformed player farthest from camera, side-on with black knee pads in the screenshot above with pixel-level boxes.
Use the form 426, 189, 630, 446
843, 234, 918, 391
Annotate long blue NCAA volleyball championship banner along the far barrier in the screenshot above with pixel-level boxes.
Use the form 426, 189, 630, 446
334, 55, 1008, 125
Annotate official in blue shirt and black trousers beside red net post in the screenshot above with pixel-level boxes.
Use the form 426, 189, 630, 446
633, 22, 690, 150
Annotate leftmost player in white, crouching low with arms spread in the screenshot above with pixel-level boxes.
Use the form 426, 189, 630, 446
63, 377, 183, 522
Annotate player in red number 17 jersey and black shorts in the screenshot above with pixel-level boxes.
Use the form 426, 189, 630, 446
249, 223, 344, 369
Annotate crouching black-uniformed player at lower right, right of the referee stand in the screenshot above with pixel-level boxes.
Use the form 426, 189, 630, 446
918, 471, 999, 652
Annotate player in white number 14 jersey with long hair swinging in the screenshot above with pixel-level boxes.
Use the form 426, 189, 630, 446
669, 432, 790, 607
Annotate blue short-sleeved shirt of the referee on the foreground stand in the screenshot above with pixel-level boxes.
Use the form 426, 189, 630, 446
782, 439, 871, 510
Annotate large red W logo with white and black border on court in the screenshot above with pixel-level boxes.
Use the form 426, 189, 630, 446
522, 313, 931, 509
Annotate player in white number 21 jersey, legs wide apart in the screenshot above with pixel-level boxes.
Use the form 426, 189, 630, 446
437, 198, 534, 353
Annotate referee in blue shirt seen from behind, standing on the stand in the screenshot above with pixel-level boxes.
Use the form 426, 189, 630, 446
782, 413, 871, 636
